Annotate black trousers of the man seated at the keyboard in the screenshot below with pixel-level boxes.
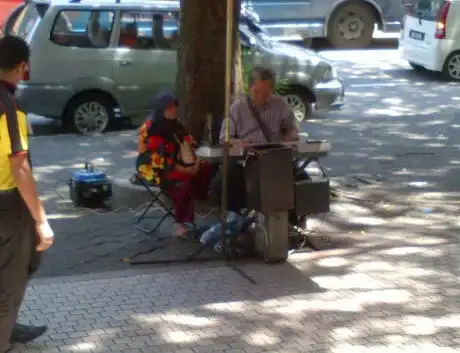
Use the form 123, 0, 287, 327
211, 160, 247, 213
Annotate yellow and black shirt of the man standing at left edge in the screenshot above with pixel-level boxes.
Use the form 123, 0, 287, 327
0, 82, 29, 191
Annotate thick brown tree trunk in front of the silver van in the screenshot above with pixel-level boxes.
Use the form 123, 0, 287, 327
177, 0, 240, 143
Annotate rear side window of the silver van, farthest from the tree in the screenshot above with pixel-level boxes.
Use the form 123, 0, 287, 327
50, 10, 115, 48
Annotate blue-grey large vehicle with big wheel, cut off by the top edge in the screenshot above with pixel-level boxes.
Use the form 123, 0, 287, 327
245, 0, 404, 48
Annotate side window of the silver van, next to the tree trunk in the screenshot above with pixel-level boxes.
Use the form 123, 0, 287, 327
118, 11, 179, 50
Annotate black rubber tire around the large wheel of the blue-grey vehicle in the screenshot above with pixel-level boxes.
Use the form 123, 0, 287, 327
327, 2, 375, 49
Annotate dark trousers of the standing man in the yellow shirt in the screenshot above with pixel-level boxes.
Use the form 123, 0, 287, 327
0, 189, 36, 352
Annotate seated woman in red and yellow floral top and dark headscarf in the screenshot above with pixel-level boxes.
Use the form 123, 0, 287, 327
137, 93, 212, 237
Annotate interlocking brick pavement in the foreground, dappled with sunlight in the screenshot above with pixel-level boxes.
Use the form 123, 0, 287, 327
12, 238, 460, 353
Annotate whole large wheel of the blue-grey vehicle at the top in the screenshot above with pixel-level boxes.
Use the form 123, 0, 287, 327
328, 2, 375, 48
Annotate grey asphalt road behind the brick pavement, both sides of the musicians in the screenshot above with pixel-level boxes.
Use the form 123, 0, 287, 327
28, 40, 460, 276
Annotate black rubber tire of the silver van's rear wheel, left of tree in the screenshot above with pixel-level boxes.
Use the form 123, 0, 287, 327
63, 93, 115, 135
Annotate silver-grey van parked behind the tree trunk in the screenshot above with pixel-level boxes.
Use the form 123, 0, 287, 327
8, 0, 344, 133
